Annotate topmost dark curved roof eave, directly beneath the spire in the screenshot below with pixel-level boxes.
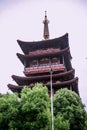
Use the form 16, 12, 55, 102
17, 33, 69, 54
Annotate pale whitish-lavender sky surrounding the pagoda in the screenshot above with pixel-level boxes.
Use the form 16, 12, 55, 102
0, 0, 87, 105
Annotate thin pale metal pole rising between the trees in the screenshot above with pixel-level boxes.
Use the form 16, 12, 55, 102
50, 68, 54, 130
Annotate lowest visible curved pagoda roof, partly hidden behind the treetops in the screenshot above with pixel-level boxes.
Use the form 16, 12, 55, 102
8, 77, 79, 94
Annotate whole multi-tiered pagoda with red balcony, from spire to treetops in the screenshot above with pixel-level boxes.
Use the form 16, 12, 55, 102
8, 12, 79, 95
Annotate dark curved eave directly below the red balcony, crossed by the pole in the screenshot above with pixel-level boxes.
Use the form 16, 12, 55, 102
12, 69, 75, 85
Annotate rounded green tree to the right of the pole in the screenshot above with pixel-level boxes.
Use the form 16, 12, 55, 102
54, 88, 87, 130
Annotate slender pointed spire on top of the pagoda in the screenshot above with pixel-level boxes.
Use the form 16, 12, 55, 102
43, 11, 49, 40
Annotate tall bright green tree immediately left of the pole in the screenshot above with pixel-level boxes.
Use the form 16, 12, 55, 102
21, 83, 51, 130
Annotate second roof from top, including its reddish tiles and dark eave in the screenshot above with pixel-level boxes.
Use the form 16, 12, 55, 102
17, 47, 69, 65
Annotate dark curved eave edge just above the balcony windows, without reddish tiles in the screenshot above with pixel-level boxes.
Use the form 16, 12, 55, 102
17, 47, 69, 65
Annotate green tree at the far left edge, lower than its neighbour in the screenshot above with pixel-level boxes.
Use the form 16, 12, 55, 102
0, 94, 19, 130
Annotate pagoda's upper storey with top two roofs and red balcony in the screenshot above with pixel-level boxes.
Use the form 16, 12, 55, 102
17, 34, 72, 76
